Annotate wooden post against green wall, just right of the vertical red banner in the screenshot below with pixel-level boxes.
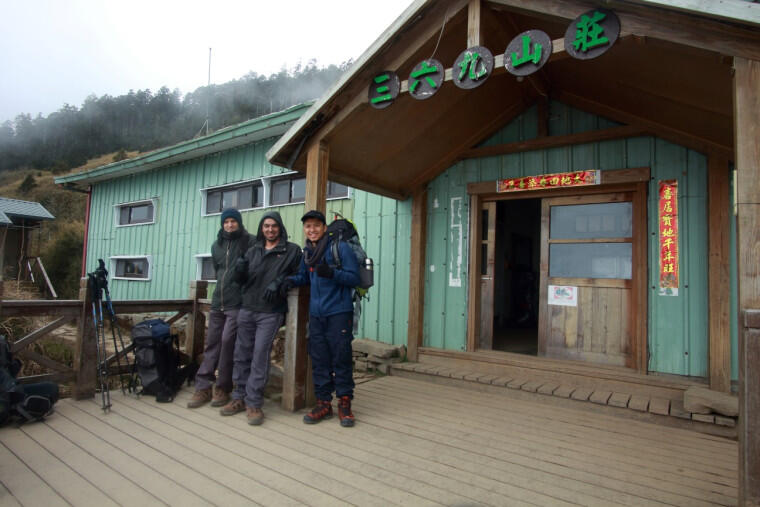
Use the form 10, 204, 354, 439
707, 154, 731, 393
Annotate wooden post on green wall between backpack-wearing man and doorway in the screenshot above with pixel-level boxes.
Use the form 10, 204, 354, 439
406, 188, 427, 361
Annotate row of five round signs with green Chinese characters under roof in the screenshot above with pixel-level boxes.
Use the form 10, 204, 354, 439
368, 9, 620, 109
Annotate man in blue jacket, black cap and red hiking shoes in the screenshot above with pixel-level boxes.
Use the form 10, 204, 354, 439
283, 210, 359, 427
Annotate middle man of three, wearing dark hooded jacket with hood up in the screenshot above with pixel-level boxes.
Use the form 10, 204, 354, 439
221, 211, 301, 425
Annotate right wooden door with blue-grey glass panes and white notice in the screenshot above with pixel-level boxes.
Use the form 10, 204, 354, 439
538, 192, 638, 367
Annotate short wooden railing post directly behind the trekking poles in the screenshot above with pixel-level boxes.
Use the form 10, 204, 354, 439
73, 277, 98, 400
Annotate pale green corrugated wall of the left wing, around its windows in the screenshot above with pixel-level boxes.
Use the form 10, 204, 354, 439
87, 135, 353, 299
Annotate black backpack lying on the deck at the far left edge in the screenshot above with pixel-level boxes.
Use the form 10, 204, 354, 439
0, 335, 58, 426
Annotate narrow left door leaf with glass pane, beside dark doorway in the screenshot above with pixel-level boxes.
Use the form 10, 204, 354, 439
478, 202, 496, 350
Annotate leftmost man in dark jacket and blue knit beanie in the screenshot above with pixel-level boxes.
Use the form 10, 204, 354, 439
187, 208, 252, 408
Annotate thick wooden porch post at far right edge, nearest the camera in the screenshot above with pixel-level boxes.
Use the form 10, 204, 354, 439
734, 57, 760, 506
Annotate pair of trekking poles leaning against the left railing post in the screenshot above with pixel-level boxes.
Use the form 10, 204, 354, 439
87, 259, 134, 412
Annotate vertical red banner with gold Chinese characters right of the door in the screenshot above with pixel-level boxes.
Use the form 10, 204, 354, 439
658, 180, 678, 296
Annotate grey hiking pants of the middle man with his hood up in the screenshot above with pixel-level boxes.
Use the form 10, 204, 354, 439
232, 309, 285, 408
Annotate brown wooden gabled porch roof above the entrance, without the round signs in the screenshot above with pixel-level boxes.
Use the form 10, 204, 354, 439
267, 0, 760, 198
